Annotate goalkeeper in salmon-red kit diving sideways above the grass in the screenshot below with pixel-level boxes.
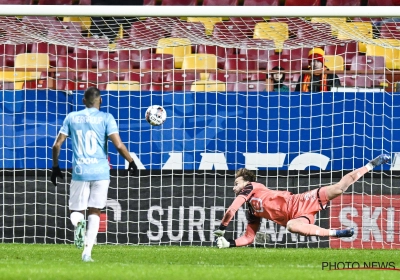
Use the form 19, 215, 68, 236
214, 154, 390, 248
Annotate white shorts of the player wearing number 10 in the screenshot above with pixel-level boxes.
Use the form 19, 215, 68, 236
69, 180, 110, 211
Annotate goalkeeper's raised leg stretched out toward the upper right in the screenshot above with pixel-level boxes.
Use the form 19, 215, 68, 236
326, 154, 390, 200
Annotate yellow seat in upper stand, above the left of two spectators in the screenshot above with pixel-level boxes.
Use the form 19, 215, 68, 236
253, 22, 289, 49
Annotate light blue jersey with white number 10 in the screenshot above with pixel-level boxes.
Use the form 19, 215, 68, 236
60, 108, 118, 181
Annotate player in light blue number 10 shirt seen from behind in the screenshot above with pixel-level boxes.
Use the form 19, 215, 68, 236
51, 87, 137, 262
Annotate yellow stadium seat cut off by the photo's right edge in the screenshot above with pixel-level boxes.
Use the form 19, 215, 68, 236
366, 39, 400, 69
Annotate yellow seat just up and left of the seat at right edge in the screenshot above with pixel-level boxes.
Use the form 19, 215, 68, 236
337, 22, 372, 52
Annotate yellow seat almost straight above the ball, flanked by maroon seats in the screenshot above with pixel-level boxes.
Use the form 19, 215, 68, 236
156, 38, 192, 68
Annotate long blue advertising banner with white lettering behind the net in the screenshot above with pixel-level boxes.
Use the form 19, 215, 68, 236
0, 90, 400, 170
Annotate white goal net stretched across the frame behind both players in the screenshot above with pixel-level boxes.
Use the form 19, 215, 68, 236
0, 6, 400, 248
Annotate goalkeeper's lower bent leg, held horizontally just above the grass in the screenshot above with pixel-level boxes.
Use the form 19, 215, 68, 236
286, 217, 354, 237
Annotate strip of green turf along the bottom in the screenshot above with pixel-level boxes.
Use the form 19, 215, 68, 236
0, 244, 400, 280
